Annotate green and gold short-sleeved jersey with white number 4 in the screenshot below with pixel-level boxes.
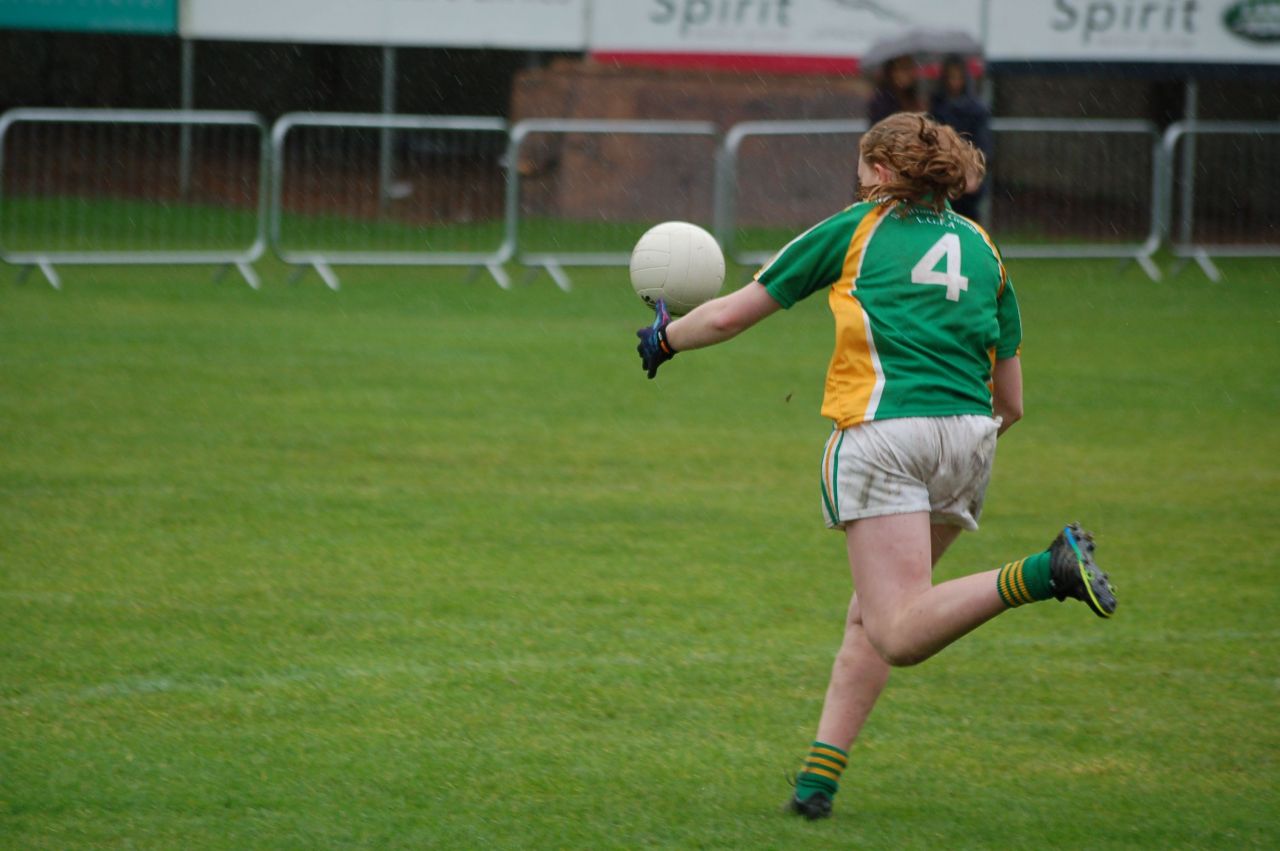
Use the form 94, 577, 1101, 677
755, 201, 1023, 429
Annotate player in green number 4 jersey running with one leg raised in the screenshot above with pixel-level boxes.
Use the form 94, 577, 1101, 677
637, 113, 1116, 819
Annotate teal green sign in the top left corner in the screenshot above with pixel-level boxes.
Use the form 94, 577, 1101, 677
0, 0, 178, 35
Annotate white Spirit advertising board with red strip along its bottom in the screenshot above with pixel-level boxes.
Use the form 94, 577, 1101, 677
588, 0, 982, 70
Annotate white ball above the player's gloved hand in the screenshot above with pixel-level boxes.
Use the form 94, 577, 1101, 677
631, 221, 724, 316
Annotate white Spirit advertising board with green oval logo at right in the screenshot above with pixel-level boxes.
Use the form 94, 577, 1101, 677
987, 0, 1280, 64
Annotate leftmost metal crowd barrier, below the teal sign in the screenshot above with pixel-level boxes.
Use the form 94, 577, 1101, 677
0, 109, 268, 289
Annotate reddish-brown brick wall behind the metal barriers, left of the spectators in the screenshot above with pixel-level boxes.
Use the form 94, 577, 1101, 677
511, 60, 870, 224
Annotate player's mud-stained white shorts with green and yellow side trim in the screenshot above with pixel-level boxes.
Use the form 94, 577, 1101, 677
822, 415, 1000, 531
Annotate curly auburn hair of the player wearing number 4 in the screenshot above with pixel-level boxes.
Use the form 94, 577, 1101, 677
858, 113, 987, 210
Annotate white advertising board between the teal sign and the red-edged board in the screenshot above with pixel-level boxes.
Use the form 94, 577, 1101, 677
179, 0, 588, 50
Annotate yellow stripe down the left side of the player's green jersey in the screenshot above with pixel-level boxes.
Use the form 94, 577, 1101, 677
822, 203, 897, 429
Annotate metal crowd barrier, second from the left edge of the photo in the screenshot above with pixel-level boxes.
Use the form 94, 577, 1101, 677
270, 113, 513, 289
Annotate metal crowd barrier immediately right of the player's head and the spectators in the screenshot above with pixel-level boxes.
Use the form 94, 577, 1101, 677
986, 118, 1162, 280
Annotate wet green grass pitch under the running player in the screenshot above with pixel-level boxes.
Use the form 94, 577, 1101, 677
0, 255, 1280, 850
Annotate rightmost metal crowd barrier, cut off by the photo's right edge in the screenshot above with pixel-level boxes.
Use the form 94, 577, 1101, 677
1161, 122, 1280, 282
